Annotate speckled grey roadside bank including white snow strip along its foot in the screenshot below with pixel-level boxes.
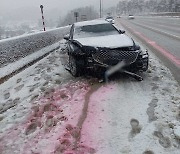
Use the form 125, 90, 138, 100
0, 27, 69, 78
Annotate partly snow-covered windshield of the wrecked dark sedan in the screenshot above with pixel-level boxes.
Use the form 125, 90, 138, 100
74, 24, 119, 38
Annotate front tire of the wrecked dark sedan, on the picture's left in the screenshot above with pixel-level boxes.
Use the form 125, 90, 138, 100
69, 54, 80, 77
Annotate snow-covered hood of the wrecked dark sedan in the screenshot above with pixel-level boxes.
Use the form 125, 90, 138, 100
74, 34, 134, 48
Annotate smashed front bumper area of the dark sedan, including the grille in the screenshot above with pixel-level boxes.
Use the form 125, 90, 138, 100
87, 51, 149, 72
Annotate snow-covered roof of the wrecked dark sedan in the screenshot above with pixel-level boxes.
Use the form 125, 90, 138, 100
74, 19, 109, 27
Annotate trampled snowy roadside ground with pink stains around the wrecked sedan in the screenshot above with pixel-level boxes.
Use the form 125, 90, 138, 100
0, 38, 180, 154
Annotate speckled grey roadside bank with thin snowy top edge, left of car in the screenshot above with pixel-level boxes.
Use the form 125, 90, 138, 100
0, 27, 69, 68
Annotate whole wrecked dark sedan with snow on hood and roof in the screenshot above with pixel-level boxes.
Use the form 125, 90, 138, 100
64, 20, 148, 80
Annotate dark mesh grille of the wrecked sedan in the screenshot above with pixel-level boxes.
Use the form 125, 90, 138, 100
92, 50, 139, 66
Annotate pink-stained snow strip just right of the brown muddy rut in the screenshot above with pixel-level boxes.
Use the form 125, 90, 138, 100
80, 84, 116, 153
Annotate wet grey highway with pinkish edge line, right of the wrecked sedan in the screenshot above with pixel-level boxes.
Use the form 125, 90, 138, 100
117, 17, 180, 83
